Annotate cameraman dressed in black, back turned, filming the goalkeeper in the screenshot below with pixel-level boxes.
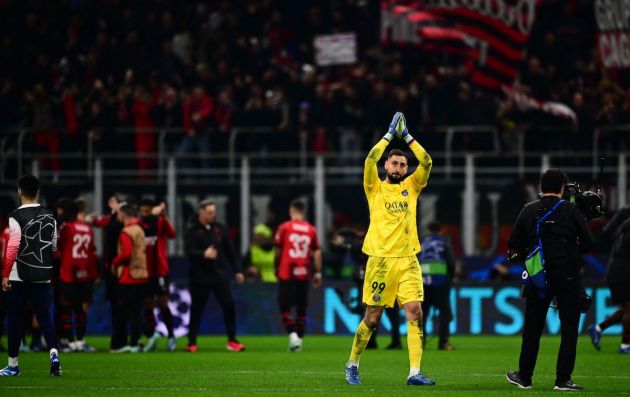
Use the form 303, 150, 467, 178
507, 169, 593, 390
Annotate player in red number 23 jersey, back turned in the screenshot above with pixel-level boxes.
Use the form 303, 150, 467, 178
57, 200, 98, 352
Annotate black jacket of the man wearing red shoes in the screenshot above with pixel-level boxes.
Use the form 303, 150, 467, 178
184, 222, 242, 284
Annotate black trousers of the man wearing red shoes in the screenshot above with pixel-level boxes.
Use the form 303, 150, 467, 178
188, 283, 236, 345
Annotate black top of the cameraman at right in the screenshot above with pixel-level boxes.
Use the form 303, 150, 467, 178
508, 196, 593, 277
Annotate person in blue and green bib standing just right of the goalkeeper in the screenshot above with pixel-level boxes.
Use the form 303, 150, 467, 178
418, 221, 456, 350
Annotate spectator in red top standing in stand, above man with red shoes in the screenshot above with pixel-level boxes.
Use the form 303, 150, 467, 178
178, 85, 215, 169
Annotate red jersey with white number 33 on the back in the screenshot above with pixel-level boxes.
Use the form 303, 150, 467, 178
275, 221, 319, 280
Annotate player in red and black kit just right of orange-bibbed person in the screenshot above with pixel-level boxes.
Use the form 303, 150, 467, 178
139, 200, 176, 352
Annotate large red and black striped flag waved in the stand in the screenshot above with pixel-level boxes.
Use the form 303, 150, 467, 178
381, 0, 539, 89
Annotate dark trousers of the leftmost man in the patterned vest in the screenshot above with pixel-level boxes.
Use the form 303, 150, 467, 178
6, 281, 57, 357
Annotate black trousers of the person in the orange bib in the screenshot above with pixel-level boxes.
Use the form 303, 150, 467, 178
112, 284, 146, 347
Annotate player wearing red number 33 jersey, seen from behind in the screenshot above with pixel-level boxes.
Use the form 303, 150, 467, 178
275, 200, 322, 351
